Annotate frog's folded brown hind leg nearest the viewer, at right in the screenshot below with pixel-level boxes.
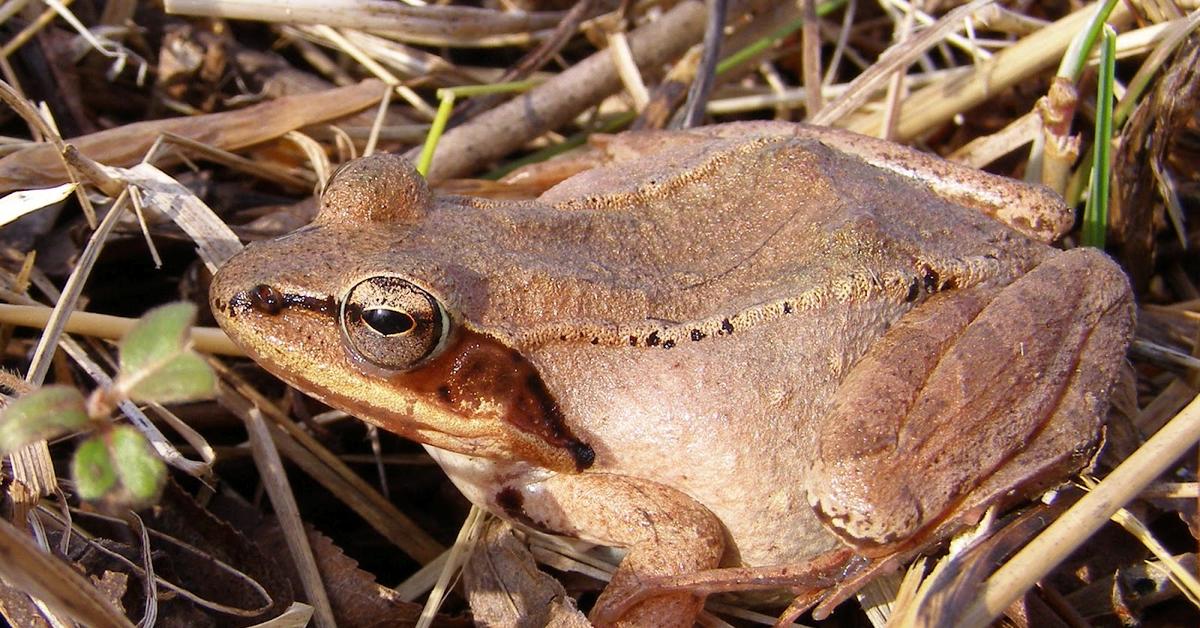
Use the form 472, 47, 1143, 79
805, 249, 1133, 551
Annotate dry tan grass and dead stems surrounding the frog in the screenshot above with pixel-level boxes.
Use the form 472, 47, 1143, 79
0, 0, 1200, 627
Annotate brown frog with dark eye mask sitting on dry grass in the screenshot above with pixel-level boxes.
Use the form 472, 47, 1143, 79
210, 121, 1134, 626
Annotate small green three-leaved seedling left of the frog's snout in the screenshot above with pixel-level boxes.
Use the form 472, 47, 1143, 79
0, 303, 216, 508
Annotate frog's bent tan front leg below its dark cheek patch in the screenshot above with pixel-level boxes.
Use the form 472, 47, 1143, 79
496, 473, 725, 627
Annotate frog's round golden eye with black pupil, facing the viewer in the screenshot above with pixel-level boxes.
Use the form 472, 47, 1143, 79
341, 276, 450, 371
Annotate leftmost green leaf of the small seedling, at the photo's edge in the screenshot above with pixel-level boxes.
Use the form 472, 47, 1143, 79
0, 385, 88, 453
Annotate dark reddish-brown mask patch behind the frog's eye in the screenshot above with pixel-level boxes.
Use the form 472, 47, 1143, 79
390, 329, 595, 471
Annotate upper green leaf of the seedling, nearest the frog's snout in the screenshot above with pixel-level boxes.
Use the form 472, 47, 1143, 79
115, 303, 216, 403
